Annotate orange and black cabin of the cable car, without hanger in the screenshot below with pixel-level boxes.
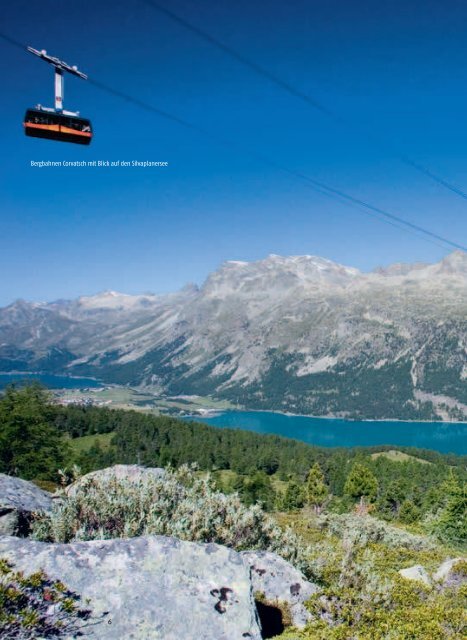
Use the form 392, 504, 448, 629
23, 109, 92, 144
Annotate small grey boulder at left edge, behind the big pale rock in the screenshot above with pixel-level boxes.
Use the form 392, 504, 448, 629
0, 473, 52, 536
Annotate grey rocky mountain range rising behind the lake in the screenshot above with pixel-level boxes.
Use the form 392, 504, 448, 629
0, 251, 467, 420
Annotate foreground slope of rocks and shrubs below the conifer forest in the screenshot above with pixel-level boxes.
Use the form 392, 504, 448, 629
0, 465, 466, 640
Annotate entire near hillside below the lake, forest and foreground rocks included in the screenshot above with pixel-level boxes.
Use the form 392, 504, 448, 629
0, 385, 467, 640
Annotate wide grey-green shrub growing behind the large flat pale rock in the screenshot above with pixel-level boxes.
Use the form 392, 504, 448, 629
33, 465, 307, 572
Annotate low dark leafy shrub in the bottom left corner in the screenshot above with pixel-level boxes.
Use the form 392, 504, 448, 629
0, 559, 95, 640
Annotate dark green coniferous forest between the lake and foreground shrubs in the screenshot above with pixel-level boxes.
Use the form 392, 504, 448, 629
0, 385, 467, 542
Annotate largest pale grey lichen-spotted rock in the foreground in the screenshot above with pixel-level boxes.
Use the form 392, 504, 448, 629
0, 536, 261, 640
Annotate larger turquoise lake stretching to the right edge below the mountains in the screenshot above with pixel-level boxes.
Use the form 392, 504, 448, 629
191, 411, 467, 455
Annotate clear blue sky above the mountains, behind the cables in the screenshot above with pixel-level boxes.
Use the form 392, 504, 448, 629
0, 0, 467, 304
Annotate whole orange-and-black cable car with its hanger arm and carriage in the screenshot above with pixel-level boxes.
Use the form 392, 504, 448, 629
23, 47, 92, 145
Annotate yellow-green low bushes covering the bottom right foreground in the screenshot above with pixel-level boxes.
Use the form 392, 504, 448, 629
274, 504, 467, 640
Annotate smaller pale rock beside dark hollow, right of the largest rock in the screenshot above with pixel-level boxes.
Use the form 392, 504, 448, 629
241, 551, 318, 627
